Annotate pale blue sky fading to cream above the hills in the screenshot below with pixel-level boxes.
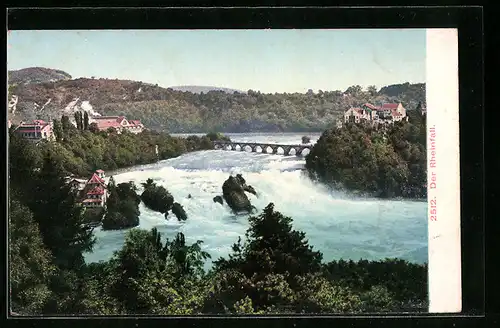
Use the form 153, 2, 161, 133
7, 29, 426, 93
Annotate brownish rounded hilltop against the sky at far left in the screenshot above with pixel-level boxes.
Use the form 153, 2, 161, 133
8, 67, 71, 84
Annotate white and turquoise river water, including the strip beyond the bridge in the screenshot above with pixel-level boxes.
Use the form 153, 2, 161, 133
86, 134, 427, 268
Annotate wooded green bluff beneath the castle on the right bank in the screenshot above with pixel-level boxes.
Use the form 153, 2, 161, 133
306, 105, 427, 199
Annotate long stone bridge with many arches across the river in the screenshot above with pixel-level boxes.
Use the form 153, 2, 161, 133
214, 141, 312, 156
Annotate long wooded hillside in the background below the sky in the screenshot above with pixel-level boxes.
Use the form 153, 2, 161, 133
9, 72, 425, 133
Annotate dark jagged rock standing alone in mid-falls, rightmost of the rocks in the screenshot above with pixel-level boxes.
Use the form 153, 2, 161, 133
222, 174, 257, 212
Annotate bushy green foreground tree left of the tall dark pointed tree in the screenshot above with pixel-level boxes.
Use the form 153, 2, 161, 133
108, 228, 208, 314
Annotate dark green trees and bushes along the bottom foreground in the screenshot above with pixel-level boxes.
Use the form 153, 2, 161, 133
11, 193, 426, 315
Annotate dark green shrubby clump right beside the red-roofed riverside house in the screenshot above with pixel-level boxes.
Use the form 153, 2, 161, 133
102, 177, 141, 230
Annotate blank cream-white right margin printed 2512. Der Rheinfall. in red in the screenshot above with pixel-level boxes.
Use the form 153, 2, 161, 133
426, 29, 462, 313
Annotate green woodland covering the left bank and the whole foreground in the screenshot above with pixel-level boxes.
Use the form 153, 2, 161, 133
9, 119, 427, 315
